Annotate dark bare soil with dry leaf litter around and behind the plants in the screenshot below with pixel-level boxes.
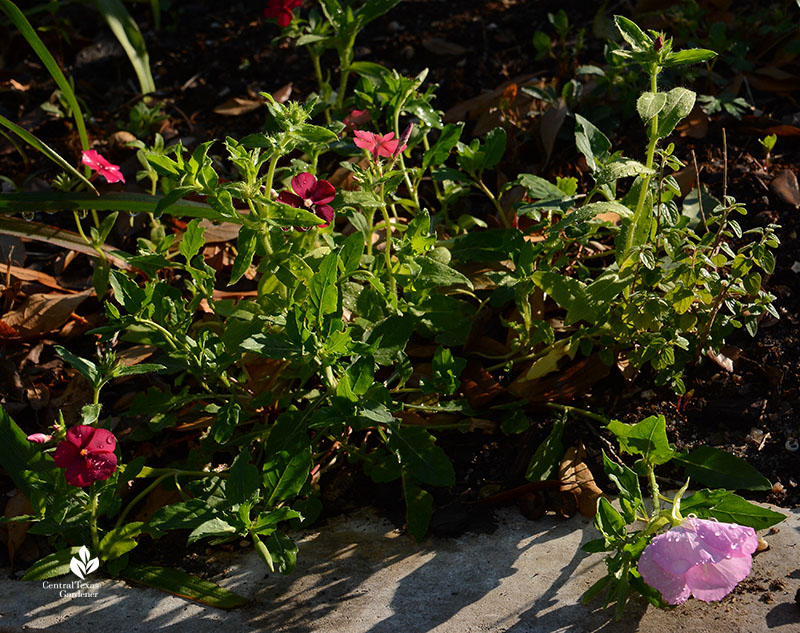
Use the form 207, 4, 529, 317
0, 0, 800, 563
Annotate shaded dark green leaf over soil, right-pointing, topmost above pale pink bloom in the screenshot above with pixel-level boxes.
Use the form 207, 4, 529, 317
674, 446, 772, 490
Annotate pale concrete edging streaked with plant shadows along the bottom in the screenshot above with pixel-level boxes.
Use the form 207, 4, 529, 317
0, 508, 800, 633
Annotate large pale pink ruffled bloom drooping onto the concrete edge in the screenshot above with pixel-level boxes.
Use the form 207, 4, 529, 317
639, 518, 758, 604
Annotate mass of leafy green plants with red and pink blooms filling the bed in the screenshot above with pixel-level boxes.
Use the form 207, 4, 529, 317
0, 0, 796, 613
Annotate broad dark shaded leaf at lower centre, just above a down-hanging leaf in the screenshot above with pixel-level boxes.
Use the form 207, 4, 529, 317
388, 426, 456, 486
